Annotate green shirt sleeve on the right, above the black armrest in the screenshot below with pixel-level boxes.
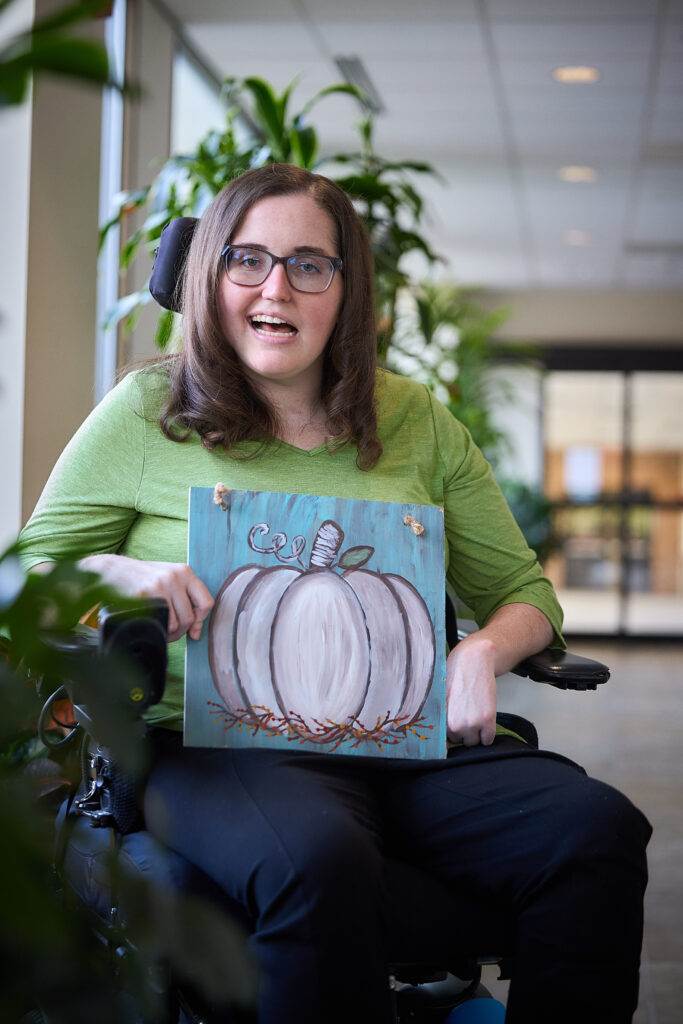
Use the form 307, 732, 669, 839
431, 387, 564, 647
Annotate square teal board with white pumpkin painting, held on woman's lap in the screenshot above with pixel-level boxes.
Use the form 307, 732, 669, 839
184, 484, 446, 758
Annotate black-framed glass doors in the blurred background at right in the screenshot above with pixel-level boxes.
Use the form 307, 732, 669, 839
544, 371, 683, 636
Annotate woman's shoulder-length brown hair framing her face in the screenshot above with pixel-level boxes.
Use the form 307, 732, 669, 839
161, 164, 382, 469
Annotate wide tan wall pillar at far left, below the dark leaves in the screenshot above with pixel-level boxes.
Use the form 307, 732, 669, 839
22, 0, 102, 519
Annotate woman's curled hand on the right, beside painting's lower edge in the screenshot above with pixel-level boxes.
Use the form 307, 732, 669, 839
445, 633, 498, 746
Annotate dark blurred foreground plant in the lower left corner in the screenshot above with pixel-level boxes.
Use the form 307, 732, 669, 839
0, 548, 255, 1024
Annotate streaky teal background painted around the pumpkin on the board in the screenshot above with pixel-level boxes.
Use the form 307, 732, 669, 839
184, 487, 446, 758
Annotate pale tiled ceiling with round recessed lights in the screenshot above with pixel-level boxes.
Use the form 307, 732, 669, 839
165, 0, 683, 289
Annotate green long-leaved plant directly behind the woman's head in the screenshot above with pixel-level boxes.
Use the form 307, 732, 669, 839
100, 78, 444, 355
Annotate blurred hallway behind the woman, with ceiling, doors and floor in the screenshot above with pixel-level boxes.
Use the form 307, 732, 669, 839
0, 0, 683, 1024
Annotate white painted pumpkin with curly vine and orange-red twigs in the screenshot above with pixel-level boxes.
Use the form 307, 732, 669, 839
208, 519, 435, 749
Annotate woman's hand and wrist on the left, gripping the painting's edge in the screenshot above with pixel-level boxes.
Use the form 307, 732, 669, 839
79, 555, 214, 643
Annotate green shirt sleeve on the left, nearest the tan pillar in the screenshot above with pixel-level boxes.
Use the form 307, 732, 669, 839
19, 374, 145, 569
